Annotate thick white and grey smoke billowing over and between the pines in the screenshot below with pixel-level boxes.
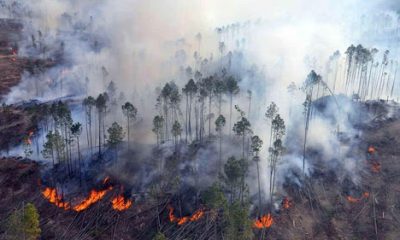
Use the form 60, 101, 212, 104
0, 0, 399, 205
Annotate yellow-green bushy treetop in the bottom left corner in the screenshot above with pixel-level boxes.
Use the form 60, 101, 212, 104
6, 203, 41, 240
